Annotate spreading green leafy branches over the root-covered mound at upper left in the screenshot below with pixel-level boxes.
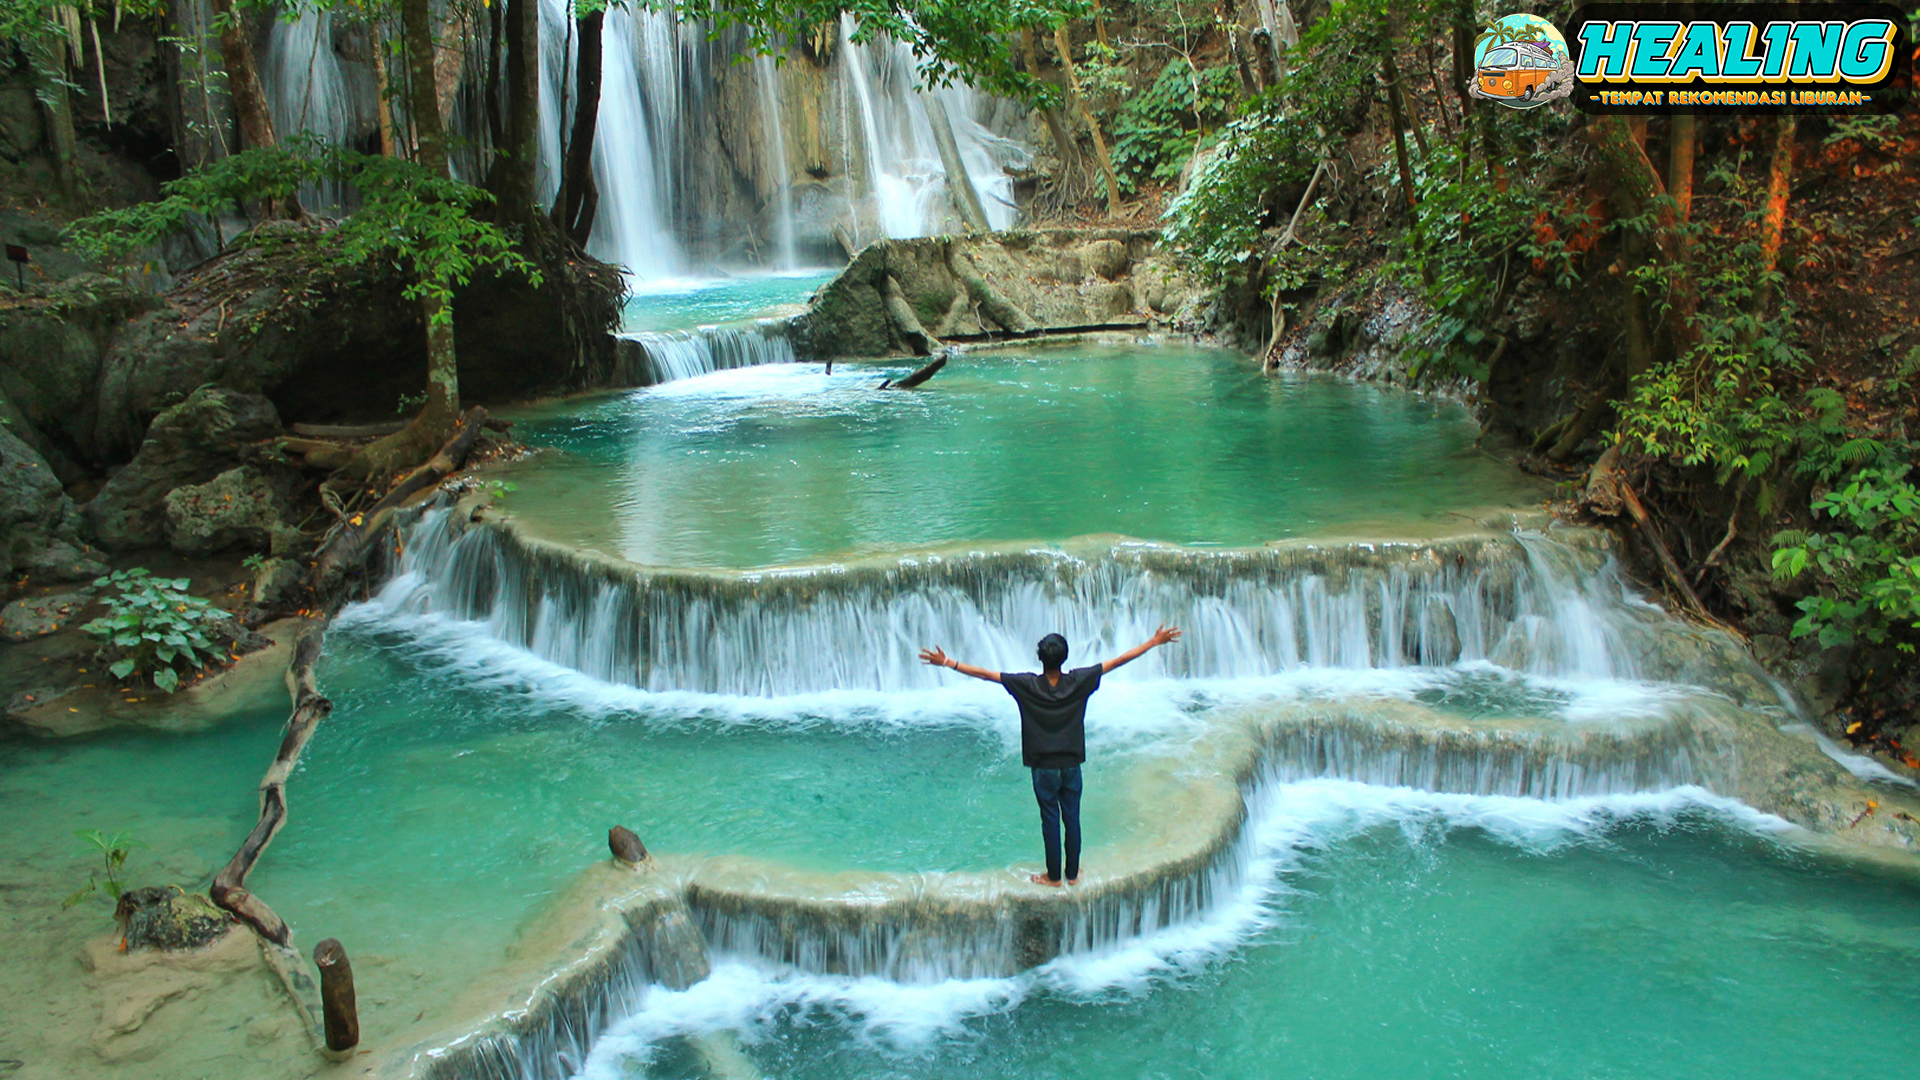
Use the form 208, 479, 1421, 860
67, 135, 540, 319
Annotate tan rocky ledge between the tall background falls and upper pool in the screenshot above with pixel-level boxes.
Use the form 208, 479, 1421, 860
797, 229, 1202, 359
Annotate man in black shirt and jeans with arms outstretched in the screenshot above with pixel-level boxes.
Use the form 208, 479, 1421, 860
920, 626, 1181, 888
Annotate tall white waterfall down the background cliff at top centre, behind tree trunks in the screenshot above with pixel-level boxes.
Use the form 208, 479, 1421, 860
540, 0, 1031, 279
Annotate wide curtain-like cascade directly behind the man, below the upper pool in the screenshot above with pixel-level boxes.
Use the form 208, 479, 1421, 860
366, 511, 1772, 703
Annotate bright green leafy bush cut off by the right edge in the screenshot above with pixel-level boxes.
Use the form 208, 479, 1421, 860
1774, 465, 1920, 653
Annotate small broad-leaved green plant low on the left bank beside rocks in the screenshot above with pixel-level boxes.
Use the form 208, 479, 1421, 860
81, 567, 227, 694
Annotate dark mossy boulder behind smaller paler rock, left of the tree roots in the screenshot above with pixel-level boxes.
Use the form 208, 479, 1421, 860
86, 386, 280, 550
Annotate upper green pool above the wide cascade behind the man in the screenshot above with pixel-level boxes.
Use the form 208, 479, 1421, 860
507, 344, 1544, 567
